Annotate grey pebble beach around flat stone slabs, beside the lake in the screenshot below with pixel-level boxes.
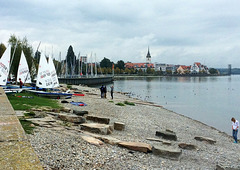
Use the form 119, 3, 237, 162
27, 86, 240, 169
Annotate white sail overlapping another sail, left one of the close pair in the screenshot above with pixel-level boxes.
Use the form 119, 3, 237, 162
36, 54, 53, 88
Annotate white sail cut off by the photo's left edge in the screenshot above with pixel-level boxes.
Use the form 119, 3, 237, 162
0, 46, 11, 85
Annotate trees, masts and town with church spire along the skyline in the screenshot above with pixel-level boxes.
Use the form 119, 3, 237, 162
0, 35, 234, 77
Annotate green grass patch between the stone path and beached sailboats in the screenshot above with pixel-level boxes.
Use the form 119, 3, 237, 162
8, 92, 61, 110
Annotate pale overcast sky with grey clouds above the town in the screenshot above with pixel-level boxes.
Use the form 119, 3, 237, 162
0, 0, 240, 68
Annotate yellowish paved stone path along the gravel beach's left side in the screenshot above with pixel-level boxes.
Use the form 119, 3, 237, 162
0, 87, 43, 170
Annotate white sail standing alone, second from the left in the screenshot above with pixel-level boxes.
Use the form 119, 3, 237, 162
17, 51, 31, 83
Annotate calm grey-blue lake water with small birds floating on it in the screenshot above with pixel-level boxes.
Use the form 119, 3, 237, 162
92, 75, 240, 134
